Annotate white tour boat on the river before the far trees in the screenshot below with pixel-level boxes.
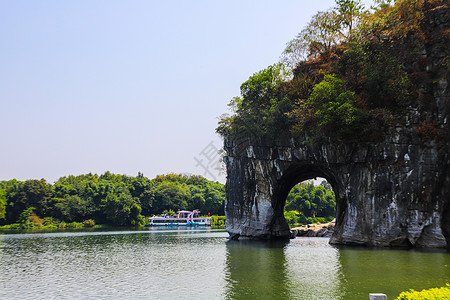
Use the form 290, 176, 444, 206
148, 210, 211, 226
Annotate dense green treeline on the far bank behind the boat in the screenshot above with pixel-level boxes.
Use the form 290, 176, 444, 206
0, 172, 225, 227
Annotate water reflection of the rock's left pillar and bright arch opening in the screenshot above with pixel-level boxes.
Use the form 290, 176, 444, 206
226, 238, 344, 299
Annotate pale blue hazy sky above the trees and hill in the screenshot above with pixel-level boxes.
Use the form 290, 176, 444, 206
0, 0, 370, 183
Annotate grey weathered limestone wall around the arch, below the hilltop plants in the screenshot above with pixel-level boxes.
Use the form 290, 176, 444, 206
226, 132, 450, 247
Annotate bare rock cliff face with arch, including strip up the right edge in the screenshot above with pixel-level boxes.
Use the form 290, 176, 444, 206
224, 6, 450, 247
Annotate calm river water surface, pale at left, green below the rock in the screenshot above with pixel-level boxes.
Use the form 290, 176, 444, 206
0, 228, 450, 299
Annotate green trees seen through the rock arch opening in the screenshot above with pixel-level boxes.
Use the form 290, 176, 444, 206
284, 181, 336, 224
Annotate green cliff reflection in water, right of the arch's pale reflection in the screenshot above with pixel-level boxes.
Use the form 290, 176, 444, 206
339, 247, 450, 299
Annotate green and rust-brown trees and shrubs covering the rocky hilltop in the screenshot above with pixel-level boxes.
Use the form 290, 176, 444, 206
216, 0, 449, 141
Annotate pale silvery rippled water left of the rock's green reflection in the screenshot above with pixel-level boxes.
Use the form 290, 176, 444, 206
0, 230, 226, 299
